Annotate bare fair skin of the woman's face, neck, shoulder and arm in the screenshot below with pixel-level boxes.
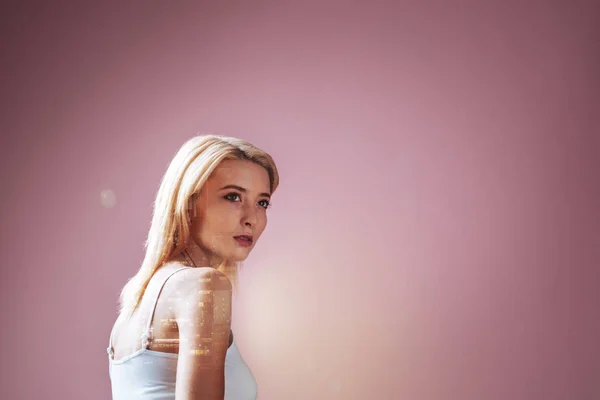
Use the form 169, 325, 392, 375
113, 160, 270, 400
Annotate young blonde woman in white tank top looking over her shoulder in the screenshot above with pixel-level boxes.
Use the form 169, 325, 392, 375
107, 135, 279, 400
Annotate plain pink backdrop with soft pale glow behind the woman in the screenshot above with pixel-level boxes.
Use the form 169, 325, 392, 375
0, 1, 600, 400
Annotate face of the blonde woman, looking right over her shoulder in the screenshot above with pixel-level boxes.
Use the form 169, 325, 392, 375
190, 160, 270, 264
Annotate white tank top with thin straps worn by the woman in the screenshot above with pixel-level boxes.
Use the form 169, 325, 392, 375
106, 267, 258, 400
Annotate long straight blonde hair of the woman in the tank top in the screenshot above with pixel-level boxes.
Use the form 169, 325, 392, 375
119, 135, 279, 318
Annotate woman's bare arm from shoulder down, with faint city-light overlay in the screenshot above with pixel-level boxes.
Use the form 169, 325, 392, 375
175, 267, 231, 400
